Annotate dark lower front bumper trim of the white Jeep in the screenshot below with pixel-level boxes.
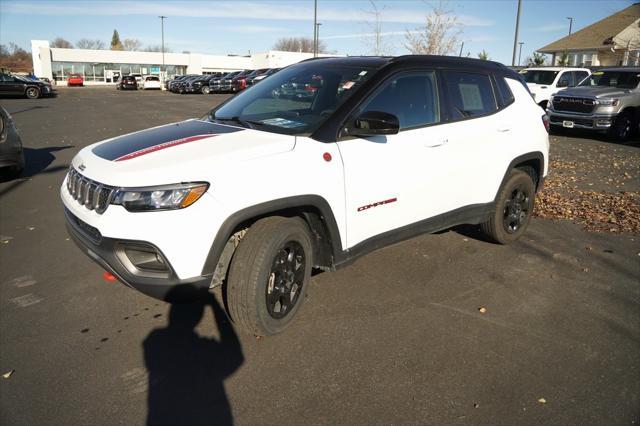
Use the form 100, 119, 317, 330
64, 208, 212, 301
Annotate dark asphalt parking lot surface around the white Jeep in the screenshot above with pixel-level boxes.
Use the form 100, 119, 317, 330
0, 87, 640, 425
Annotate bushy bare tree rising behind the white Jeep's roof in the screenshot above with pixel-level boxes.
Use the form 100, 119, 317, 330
404, 1, 462, 55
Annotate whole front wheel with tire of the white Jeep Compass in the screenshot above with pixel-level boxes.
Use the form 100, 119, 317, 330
226, 217, 313, 336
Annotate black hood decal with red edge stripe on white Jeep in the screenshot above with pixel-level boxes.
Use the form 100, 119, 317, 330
91, 120, 244, 161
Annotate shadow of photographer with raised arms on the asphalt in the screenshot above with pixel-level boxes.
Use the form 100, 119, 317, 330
142, 293, 244, 425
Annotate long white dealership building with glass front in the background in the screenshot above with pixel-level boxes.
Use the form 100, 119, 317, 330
31, 40, 320, 84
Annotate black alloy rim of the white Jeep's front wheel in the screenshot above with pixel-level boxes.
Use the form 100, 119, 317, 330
266, 241, 305, 319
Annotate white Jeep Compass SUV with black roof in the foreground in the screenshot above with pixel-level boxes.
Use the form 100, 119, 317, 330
60, 55, 549, 335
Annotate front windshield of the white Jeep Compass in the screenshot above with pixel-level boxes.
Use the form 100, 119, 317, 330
210, 61, 376, 135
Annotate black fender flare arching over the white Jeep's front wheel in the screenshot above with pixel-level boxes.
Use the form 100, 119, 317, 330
202, 194, 342, 274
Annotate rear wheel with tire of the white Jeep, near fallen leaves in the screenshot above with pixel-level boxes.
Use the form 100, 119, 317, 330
480, 169, 535, 244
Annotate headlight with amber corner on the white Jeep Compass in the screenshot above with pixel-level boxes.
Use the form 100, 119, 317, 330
111, 182, 209, 212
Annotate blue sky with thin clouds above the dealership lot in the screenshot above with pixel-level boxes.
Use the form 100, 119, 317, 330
0, 0, 634, 65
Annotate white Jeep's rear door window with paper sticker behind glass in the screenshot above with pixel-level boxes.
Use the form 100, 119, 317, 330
444, 71, 498, 120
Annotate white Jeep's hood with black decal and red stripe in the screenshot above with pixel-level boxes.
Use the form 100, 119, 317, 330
72, 120, 295, 186
